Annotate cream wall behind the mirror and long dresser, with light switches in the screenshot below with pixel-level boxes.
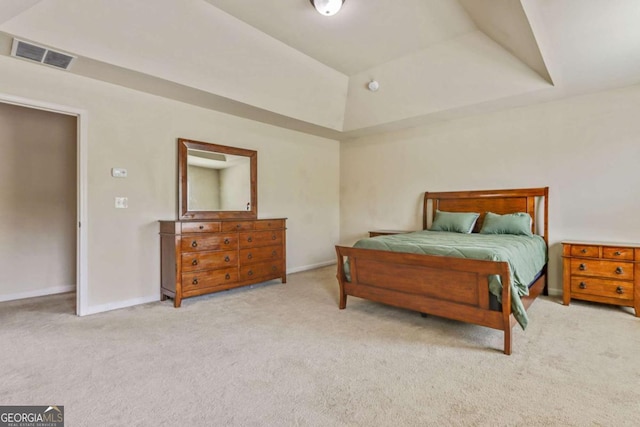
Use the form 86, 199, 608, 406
0, 57, 339, 312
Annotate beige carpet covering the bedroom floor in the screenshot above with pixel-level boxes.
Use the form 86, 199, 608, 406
0, 267, 640, 427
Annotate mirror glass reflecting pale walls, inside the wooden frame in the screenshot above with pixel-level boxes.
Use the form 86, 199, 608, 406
187, 149, 251, 211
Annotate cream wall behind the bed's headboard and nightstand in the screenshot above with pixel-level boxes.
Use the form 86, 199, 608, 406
340, 86, 640, 292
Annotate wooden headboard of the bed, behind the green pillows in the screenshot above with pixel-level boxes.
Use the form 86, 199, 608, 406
422, 187, 549, 245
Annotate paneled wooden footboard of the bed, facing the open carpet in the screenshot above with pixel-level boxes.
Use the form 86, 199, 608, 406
336, 246, 520, 354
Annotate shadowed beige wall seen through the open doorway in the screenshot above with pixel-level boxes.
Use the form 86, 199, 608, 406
0, 103, 77, 301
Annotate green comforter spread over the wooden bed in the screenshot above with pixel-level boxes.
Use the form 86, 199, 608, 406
345, 230, 547, 329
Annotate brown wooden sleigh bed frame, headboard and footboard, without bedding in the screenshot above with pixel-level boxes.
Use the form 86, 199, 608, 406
336, 187, 549, 355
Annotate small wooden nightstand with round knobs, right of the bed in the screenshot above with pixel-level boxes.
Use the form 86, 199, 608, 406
562, 241, 640, 316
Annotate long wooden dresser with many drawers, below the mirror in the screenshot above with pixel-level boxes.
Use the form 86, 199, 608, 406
160, 218, 287, 307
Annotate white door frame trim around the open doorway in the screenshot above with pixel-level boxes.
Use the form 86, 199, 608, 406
0, 93, 89, 316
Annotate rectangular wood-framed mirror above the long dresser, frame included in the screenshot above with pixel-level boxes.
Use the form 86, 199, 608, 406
178, 138, 258, 219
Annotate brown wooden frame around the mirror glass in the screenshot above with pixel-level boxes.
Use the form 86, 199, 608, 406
178, 138, 258, 220
